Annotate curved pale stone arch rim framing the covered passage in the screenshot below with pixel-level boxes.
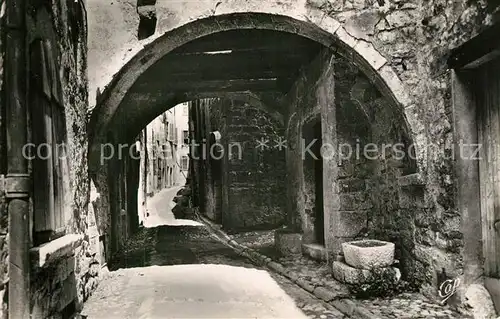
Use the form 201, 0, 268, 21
89, 8, 420, 175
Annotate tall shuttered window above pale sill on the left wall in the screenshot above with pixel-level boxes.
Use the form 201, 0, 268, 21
29, 39, 69, 246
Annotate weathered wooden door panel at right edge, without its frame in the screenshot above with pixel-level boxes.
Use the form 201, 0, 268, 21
478, 58, 500, 307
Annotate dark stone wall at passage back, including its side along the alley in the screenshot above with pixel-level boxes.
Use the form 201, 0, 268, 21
197, 98, 285, 231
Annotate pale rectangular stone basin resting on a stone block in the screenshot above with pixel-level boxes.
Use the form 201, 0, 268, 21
342, 239, 395, 269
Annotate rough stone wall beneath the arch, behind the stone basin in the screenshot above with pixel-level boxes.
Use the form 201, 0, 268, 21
288, 52, 427, 284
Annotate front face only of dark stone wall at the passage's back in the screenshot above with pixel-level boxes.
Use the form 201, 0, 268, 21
224, 100, 286, 230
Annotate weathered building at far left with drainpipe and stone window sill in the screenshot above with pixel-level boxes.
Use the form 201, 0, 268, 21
0, 1, 101, 318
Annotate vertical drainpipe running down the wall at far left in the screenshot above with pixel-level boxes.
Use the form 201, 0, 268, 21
4, 0, 30, 319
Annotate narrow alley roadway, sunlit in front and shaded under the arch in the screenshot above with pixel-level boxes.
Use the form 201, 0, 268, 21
82, 191, 345, 319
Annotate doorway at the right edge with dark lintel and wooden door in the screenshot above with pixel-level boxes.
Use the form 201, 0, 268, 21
456, 30, 500, 312
